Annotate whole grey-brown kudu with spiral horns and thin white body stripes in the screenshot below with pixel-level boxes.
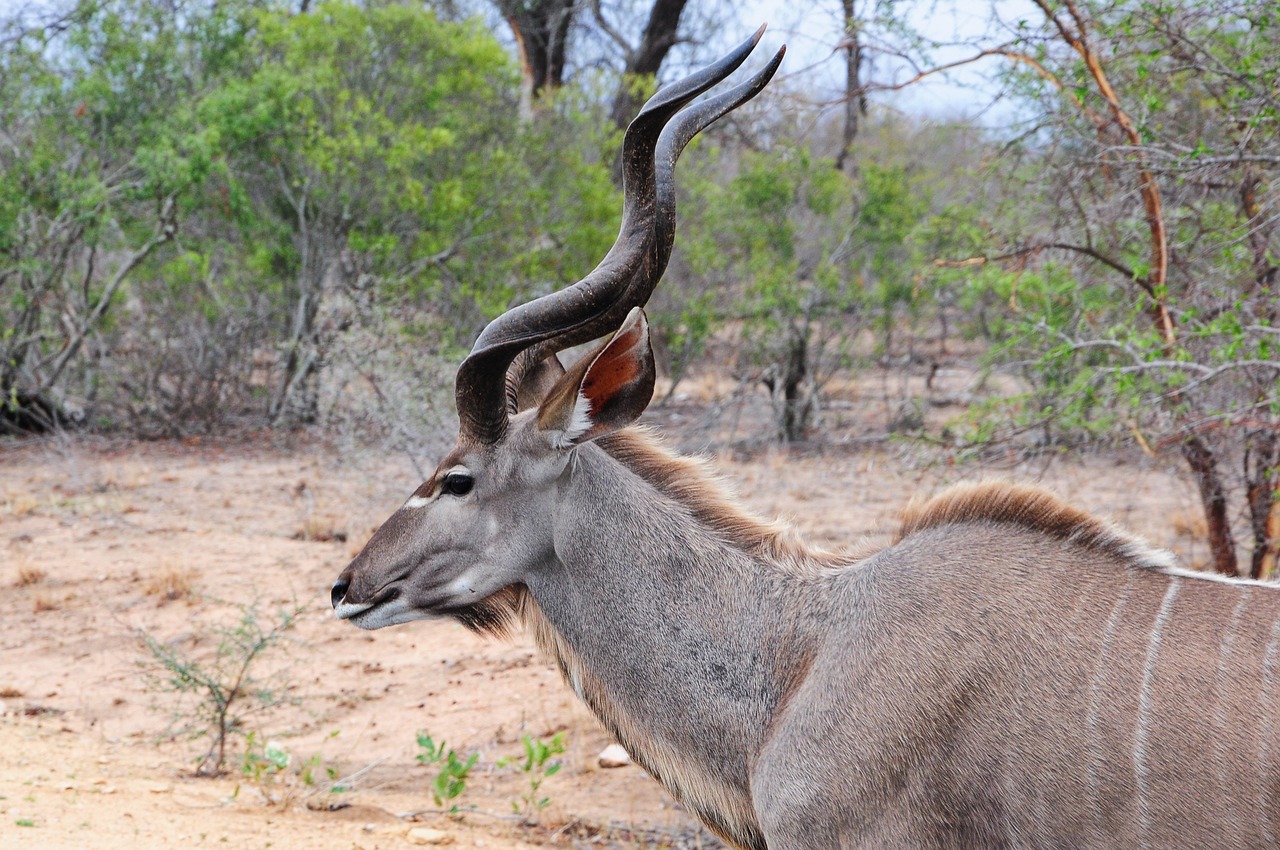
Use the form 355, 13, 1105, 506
333, 26, 1280, 850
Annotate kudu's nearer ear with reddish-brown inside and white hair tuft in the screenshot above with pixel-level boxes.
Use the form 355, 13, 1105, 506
538, 307, 654, 448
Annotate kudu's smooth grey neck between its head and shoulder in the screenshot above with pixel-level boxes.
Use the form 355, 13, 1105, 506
517, 437, 826, 834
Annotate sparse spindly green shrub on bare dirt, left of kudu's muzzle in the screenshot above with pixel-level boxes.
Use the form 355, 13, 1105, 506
138, 605, 302, 776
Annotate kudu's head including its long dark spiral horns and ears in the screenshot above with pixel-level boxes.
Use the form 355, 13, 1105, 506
333, 27, 785, 630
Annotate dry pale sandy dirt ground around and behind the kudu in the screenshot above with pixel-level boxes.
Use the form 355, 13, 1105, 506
0, 413, 1204, 850
